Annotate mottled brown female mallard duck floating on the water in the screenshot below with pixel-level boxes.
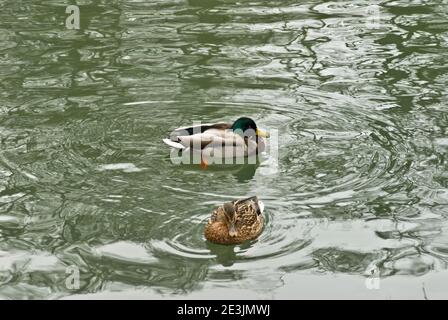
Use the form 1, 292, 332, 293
204, 197, 264, 244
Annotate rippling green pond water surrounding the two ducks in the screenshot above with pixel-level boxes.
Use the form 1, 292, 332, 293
0, 0, 448, 299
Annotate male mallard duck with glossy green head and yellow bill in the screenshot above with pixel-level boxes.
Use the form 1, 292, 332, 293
163, 117, 268, 169
